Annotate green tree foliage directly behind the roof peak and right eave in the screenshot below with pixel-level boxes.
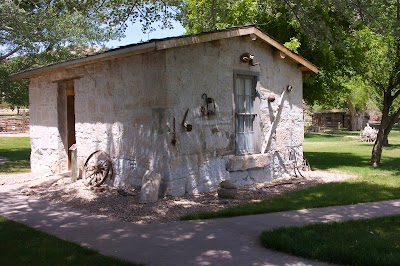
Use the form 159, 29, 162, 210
182, 0, 356, 105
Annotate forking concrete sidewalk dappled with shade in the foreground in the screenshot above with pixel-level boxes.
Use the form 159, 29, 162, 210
0, 182, 400, 265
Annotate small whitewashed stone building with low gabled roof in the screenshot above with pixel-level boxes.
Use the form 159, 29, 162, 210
13, 26, 318, 196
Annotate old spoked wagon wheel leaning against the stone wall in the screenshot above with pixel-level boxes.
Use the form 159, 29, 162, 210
82, 150, 113, 187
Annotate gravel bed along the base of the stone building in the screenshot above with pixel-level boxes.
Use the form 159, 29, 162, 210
0, 171, 352, 224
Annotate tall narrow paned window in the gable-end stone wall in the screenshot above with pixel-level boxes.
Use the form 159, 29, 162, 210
235, 75, 258, 155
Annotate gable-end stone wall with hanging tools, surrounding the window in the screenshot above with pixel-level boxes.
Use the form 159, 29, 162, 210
163, 37, 303, 195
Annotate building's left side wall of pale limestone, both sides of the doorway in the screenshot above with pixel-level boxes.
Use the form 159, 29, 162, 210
30, 52, 168, 183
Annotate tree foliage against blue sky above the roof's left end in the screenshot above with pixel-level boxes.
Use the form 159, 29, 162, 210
0, 0, 119, 62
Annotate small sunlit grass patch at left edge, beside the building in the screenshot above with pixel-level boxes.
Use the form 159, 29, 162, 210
0, 137, 31, 174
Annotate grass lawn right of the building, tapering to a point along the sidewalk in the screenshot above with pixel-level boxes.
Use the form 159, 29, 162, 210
181, 131, 400, 220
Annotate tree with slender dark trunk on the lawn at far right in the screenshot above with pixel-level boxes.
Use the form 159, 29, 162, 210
255, 0, 400, 167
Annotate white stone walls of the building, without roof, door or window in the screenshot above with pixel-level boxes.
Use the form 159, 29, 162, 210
30, 37, 303, 196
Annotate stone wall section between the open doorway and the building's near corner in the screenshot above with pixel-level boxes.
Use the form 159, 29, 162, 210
75, 51, 168, 186
